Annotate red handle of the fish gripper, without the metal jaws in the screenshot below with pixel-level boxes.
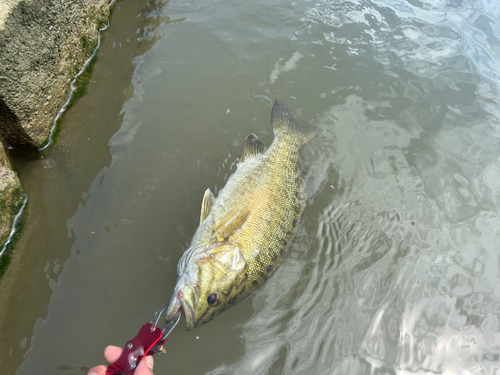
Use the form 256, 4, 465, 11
106, 323, 165, 375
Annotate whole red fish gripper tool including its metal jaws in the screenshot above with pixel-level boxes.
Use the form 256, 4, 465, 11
106, 305, 180, 375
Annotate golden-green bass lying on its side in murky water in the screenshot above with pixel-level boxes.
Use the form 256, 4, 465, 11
165, 100, 320, 331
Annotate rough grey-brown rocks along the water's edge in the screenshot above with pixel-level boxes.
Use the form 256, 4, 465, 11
0, 0, 109, 275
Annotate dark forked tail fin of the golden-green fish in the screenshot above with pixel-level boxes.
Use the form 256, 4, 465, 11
271, 100, 321, 143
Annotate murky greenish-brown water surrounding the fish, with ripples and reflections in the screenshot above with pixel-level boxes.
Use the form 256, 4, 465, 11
0, 0, 500, 375
